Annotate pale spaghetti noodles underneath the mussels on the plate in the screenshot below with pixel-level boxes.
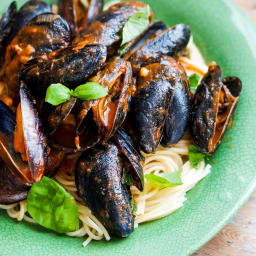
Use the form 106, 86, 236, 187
0, 38, 210, 246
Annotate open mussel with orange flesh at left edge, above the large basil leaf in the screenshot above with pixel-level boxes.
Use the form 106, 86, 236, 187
0, 84, 48, 185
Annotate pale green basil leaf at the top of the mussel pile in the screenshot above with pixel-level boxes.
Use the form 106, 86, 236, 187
121, 5, 150, 46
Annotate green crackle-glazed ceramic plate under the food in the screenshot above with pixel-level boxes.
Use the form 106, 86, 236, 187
0, 0, 256, 256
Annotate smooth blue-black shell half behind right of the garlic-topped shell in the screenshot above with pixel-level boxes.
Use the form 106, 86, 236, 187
161, 58, 190, 146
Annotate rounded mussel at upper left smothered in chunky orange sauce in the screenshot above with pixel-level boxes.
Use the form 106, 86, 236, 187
4, 13, 71, 101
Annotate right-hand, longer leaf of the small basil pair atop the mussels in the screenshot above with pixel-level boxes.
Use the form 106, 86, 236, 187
73, 82, 108, 100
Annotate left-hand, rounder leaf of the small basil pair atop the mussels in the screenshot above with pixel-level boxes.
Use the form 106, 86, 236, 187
45, 84, 71, 106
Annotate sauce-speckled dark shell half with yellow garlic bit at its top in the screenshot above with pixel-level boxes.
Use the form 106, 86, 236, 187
129, 63, 175, 153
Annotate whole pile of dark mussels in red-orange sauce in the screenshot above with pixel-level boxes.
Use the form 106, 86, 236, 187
0, 0, 242, 237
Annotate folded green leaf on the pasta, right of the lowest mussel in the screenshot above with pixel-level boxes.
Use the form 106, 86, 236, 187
145, 169, 183, 188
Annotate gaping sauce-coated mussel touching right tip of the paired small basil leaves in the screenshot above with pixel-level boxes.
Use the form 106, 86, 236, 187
92, 60, 135, 141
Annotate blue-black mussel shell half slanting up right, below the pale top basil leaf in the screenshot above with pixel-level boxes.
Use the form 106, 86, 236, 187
129, 24, 190, 72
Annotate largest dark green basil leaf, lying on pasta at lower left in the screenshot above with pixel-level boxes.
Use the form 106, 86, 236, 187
27, 176, 79, 233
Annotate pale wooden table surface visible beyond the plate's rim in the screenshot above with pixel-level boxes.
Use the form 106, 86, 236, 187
193, 0, 256, 256
